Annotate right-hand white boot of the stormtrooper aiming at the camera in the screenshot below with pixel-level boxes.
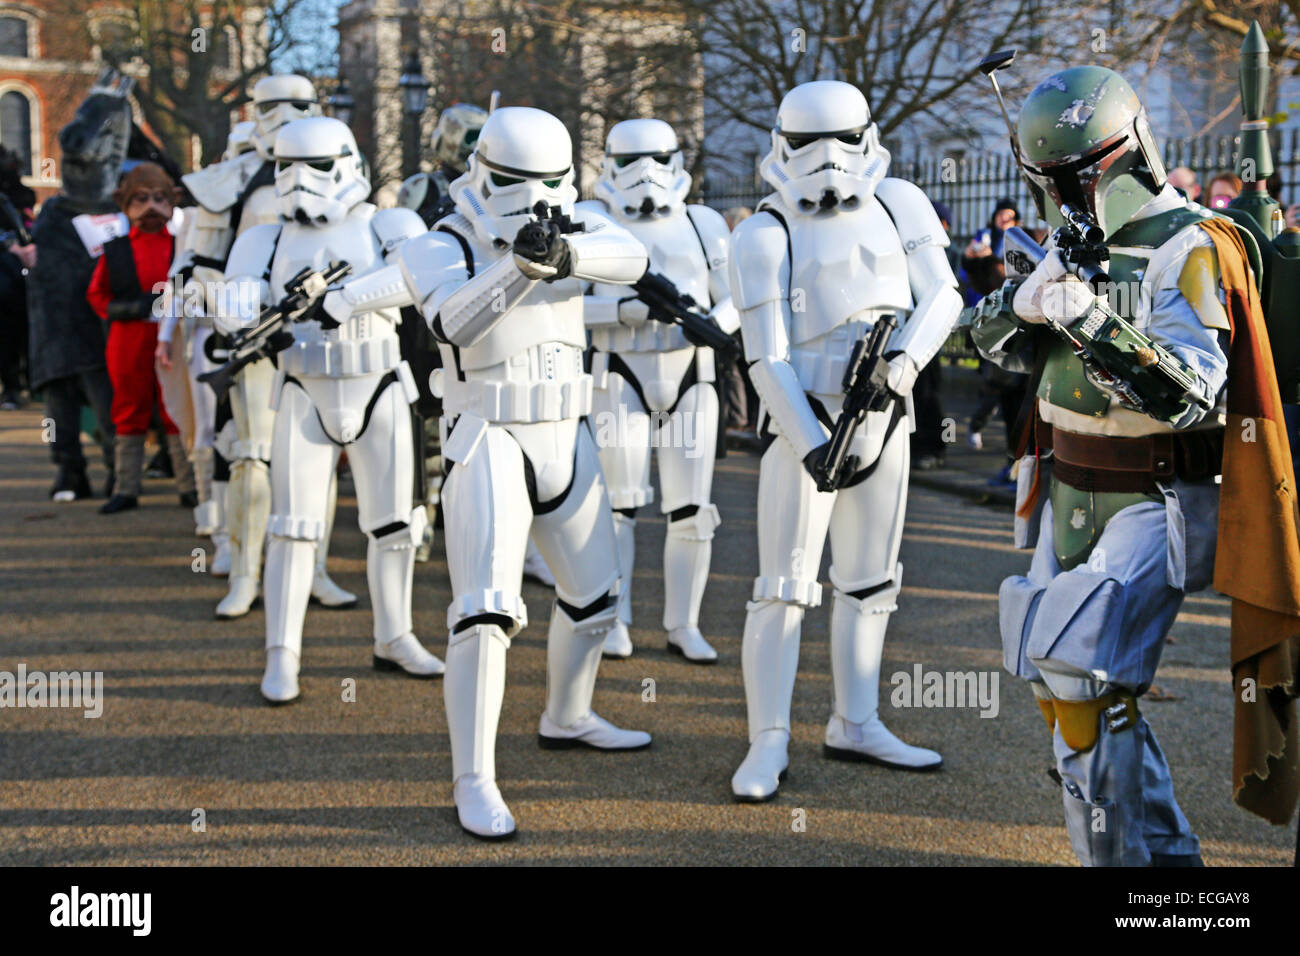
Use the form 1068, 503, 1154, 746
537, 602, 650, 750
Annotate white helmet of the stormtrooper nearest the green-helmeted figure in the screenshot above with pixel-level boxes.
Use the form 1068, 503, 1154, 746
759, 79, 889, 212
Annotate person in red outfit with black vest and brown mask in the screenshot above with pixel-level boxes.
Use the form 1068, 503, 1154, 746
86, 163, 198, 514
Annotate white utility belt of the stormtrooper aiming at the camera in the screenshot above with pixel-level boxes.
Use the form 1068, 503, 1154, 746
429, 368, 592, 421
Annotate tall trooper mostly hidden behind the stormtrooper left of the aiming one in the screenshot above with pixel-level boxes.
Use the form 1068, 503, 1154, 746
173, 74, 356, 619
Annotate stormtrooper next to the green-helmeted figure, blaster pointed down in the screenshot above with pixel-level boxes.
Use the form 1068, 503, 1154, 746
731, 81, 962, 801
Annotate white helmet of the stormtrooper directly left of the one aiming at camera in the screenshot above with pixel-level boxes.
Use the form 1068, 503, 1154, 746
276, 116, 371, 225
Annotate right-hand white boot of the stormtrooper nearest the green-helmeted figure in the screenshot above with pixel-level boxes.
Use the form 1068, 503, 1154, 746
823, 566, 944, 770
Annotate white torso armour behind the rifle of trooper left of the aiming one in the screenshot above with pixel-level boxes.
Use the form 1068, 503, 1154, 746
269, 204, 402, 378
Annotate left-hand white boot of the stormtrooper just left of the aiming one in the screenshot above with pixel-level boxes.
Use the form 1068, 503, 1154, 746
261, 516, 319, 704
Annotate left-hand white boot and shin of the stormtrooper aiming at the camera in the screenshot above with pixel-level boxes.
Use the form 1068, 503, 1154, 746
442, 624, 515, 840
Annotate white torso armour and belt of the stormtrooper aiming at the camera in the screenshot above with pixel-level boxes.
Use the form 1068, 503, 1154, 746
434, 229, 592, 421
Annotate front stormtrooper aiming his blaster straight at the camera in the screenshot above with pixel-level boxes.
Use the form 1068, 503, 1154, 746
325, 107, 650, 839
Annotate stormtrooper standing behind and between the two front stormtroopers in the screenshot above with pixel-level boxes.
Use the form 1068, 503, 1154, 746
579, 120, 740, 663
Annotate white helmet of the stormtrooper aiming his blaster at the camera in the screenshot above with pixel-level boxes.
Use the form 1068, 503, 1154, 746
450, 107, 577, 248
